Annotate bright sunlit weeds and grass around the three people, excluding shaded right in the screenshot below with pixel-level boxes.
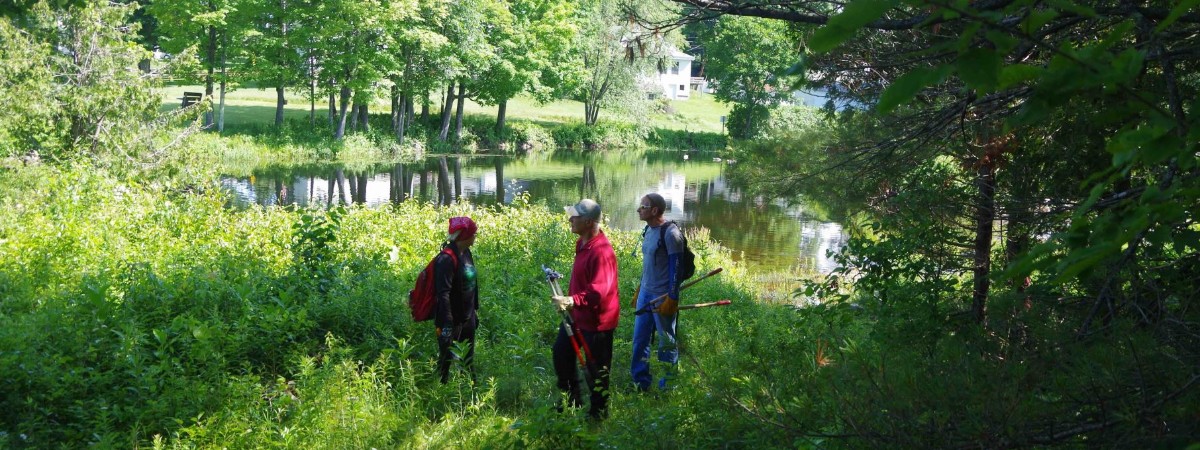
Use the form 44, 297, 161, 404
0, 167, 816, 448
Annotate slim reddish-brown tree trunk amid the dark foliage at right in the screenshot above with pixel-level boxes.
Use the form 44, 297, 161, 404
971, 158, 996, 324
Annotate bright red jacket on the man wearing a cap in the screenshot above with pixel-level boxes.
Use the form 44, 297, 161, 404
566, 232, 620, 331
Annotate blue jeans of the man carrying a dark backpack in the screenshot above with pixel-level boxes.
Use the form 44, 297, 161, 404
629, 290, 679, 390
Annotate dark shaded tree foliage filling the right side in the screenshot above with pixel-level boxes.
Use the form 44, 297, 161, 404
678, 0, 1200, 448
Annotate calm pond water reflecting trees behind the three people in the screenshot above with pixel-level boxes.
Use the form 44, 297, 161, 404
222, 152, 847, 274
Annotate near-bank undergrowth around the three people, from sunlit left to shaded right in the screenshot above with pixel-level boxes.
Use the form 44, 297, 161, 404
7, 132, 1200, 449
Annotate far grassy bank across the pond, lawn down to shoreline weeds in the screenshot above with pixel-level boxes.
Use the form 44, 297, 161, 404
161, 86, 728, 152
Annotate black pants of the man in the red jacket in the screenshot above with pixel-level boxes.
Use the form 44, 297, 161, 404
553, 326, 612, 418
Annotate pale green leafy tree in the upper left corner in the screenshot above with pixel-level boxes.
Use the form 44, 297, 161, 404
0, 4, 194, 166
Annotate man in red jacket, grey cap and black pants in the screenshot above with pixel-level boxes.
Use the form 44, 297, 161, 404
553, 199, 620, 419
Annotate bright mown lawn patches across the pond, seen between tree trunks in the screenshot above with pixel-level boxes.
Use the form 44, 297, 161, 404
154, 85, 730, 132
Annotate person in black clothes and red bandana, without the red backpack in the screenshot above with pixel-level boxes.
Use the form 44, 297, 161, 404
433, 216, 479, 384
